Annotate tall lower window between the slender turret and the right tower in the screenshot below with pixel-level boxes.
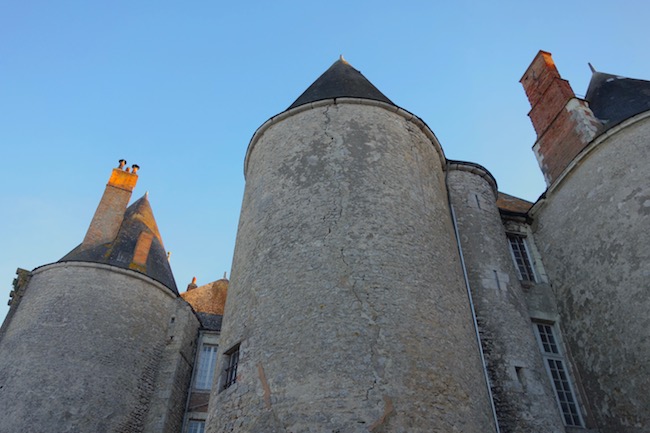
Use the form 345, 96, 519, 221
534, 323, 583, 427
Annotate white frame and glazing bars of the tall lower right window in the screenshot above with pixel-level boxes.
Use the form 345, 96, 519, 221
533, 320, 585, 427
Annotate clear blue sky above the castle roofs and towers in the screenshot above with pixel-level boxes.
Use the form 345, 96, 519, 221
0, 0, 650, 317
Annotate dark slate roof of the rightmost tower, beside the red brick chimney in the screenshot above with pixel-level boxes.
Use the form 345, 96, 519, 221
585, 72, 650, 129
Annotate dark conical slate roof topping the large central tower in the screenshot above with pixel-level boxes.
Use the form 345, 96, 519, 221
289, 57, 395, 109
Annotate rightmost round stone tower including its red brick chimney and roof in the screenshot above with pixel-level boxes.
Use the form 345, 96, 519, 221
521, 51, 650, 433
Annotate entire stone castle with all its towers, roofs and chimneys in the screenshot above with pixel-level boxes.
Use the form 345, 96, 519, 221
0, 51, 650, 433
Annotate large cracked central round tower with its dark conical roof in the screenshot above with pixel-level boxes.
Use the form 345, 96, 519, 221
207, 60, 495, 433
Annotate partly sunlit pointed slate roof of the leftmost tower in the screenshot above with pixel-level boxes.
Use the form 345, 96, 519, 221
59, 195, 178, 294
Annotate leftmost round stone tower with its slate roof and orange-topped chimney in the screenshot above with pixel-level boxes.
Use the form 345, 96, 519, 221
0, 163, 191, 433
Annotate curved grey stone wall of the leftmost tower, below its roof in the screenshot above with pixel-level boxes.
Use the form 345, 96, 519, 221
0, 262, 180, 433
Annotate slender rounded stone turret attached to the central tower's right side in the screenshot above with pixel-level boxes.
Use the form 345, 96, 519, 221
448, 163, 564, 433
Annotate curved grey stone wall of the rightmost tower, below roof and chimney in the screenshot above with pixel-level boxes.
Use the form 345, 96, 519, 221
534, 113, 650, 433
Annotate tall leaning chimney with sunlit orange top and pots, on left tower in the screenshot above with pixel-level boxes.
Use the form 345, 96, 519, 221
81, 159, 139, 249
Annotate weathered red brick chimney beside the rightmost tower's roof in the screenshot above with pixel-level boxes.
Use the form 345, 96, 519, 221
519, 51, 600, 186
